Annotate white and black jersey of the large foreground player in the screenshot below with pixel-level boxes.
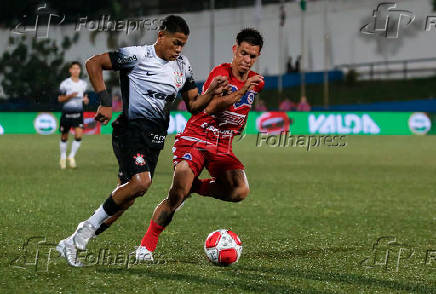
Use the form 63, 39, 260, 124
109, 45, 196, 130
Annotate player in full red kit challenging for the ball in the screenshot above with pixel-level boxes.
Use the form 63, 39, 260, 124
136, 28, 264, 261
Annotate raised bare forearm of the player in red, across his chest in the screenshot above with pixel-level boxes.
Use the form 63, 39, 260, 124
204, 75, 263, 113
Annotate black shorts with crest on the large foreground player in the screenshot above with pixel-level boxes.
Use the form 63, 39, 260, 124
112, 114, 166, 184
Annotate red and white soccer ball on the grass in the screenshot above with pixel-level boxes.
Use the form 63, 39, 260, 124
204, 229, 242, 265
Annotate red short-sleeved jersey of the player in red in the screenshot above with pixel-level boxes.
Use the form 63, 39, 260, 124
178, 63, 264, 144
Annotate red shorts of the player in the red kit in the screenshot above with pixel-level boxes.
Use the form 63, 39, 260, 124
173, 137, 244, 177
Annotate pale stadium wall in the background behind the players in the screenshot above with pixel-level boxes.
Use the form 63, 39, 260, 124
0, 0, 436, 80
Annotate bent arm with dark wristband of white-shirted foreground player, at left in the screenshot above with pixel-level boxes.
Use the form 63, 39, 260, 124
85, 53, 112, 124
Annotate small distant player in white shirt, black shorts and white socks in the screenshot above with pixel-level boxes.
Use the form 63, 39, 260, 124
58, 61, 89, 169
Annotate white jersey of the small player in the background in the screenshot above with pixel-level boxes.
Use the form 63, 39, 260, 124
59, 78, 87, 113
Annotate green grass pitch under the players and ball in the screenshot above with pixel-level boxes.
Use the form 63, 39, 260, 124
0, 135, 436, 293
